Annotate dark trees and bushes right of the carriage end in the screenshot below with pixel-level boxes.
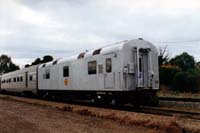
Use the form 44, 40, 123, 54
158, 47, 200, 93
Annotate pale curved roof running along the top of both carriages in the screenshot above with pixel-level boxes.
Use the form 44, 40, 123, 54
2, 39, 157, 78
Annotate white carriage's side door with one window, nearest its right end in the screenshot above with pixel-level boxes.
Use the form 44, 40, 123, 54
104, 56, 115, 89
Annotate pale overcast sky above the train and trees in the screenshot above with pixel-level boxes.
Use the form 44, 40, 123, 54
0, 0, 200, 67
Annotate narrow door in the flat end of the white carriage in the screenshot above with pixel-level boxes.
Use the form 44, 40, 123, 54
138, 49, 149, 87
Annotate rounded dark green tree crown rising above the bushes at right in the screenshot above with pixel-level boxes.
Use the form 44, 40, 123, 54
170, 52, 195, 71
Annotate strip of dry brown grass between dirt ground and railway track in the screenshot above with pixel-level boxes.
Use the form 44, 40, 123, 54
0, 96, 200, 133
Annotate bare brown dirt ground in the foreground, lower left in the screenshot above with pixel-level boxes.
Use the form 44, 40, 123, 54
0, 99, 158, 133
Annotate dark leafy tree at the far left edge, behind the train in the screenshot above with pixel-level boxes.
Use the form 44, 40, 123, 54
0, 54, 19, 73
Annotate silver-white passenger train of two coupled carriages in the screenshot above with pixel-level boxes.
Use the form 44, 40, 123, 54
1, 39, 159, 103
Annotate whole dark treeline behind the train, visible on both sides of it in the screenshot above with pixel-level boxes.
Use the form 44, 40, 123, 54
0, 47, 200, 92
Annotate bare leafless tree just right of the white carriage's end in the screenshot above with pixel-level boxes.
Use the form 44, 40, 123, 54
158, 46, 169, 66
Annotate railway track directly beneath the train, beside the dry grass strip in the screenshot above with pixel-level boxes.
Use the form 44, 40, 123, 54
0, 95, 200, 120
